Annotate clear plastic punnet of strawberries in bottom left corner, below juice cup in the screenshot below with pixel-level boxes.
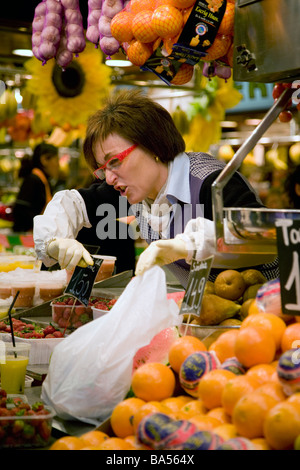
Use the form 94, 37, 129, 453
0, 389, 53, 448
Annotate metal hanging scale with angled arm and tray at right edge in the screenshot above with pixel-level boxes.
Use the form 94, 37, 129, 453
212, 0, 300, 254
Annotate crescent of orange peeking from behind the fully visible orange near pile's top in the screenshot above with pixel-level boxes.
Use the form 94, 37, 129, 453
241, 313, 286, 349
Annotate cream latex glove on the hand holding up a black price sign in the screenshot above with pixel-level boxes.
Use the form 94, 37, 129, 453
47, 238, 94, 270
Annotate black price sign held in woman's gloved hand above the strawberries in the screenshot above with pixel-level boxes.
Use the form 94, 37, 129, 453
64, 256, 103, 307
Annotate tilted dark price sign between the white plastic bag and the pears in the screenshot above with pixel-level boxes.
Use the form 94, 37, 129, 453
179, 256, 213, 317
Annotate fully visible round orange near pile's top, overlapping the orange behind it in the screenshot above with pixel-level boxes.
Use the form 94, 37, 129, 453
234, 326, 276, 367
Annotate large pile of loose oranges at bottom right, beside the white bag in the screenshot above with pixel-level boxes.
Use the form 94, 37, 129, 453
52, 308, 300, 450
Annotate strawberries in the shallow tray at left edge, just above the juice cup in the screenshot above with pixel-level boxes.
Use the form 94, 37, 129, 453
0, 318, 63, 339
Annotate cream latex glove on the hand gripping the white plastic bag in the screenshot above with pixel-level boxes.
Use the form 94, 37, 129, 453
135, 238, 188, 276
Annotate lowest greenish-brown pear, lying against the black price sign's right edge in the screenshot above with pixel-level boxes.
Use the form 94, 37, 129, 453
199, 294, 241, 325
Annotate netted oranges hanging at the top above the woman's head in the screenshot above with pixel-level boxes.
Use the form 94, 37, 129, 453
110, 0, 234, 85
